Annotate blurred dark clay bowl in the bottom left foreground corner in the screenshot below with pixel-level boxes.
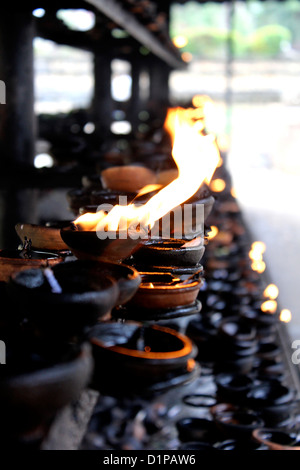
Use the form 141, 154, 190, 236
0, 343, 93, 441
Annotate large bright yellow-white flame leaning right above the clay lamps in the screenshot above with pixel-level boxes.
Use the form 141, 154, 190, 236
74, 108, 220, 238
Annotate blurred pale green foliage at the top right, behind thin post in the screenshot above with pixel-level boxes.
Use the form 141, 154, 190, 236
170, 0, 300, 59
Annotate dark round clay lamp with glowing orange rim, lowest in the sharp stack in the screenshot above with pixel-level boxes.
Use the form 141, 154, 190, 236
89, 322, 199, 396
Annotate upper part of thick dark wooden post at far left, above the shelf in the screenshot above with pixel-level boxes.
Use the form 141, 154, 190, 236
0, 8, 35, 168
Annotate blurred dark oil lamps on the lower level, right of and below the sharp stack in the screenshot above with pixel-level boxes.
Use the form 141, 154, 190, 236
79, 163, 300, 452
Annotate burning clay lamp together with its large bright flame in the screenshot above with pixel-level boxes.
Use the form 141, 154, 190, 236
61, 108, 220, 268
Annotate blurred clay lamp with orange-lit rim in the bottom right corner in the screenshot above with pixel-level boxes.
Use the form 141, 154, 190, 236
252, 428, 300, 450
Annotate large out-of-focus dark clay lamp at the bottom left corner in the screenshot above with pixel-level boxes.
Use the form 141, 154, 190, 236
0, 335, 93, 449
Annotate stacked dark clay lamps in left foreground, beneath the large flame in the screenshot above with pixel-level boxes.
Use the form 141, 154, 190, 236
0, 161, 217, 447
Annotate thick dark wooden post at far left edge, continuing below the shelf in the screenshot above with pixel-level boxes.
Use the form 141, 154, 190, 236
0, 7, 36, 248
